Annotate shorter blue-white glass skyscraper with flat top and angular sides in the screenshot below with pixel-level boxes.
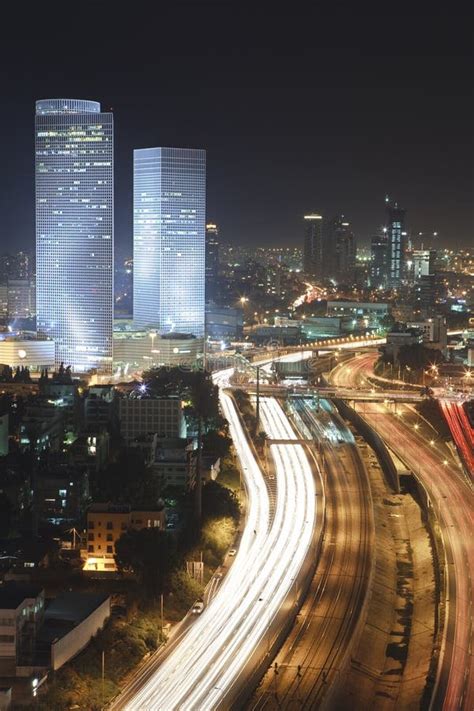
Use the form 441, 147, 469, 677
133, 148, 206, 337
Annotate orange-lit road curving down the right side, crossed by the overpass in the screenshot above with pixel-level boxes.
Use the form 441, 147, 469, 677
331, 354, 474, 711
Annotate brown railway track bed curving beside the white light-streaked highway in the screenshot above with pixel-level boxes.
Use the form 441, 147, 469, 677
249, 398, 374, 710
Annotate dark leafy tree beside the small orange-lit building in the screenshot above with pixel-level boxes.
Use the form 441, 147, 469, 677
115, 528, 177, 597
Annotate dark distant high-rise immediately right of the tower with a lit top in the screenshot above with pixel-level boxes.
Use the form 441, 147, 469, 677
323, 215, 356, 283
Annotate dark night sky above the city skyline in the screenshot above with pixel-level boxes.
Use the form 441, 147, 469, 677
0, 0, 474, 256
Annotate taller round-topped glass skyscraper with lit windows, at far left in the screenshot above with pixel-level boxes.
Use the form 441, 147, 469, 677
35, 99, 114, 372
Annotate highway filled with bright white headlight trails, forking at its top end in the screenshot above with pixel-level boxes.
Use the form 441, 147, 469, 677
112, 373, 316, 711
